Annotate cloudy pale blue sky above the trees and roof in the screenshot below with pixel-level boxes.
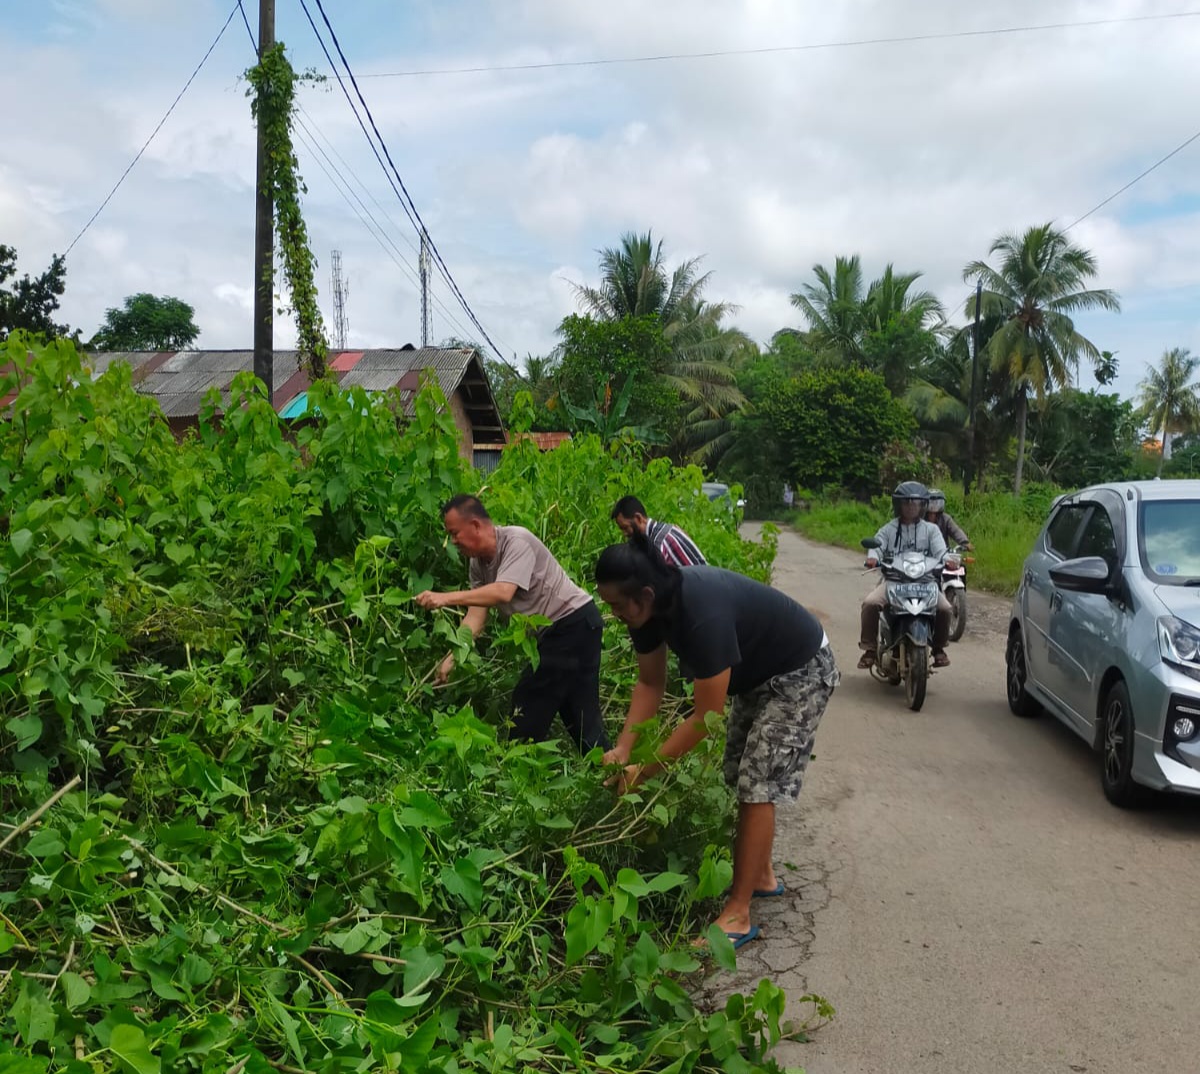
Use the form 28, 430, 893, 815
0, 0, 1200, 396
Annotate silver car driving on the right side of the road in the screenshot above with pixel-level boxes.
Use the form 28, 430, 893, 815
1007, 481, 1200, 806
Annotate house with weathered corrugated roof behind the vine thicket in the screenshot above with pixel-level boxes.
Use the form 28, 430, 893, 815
85, 344, 505, 463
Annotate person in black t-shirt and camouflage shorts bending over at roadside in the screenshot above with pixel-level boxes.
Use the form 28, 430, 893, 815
595, 534, 839, 947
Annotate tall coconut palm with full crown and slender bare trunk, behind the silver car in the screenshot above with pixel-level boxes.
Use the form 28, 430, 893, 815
962, 223, 1121, 494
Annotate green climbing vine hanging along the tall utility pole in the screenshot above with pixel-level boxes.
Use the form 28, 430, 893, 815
246, 43, 329, 380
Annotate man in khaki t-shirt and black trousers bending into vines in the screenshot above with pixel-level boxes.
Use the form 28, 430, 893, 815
416, 493, 611, 752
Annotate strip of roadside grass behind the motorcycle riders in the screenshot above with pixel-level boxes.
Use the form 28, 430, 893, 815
785, 485, 1062, 596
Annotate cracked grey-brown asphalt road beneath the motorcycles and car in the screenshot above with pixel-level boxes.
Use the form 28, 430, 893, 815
712, 533, 1200, 1074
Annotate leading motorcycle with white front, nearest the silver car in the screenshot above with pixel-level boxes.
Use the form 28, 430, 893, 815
862, 538, 941, 712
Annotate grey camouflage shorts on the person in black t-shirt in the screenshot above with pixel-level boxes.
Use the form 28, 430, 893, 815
725, 644, 841, 803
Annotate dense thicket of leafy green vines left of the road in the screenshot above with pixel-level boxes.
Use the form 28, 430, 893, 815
0, 335, 816, 1074
